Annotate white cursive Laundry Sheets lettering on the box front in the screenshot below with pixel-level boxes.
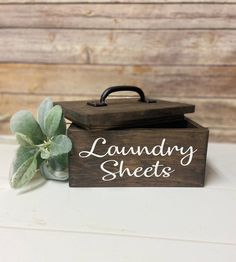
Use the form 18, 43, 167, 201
79, 137, 198, 181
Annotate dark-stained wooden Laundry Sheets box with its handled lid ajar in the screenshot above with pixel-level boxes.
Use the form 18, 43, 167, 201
57, 86, 209, 187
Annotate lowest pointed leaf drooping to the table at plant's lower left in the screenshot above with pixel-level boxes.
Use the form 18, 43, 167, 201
10, 156, 37, 188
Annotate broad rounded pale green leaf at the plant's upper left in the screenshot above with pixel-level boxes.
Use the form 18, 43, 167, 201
10, 110, 45, 144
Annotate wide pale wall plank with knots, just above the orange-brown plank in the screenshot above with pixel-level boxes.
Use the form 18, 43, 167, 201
0, 29, 236, 65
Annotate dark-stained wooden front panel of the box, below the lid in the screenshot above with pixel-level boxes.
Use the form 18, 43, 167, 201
68, 118, 208, 187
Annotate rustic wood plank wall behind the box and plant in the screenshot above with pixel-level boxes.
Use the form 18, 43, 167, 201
0, 0, 236, 142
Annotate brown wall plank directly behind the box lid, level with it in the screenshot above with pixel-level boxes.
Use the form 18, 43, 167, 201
0, 94, 236, 129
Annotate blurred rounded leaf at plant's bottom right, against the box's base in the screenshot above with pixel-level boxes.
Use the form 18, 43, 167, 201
40, 160, 69, 181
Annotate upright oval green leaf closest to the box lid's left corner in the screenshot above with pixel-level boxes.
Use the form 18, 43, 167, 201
44, 105, 62, 138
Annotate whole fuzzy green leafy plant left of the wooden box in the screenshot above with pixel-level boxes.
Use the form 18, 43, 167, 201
10, 98, 72, 188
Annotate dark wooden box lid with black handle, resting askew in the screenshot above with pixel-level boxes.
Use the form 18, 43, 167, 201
55, 86, 195, 130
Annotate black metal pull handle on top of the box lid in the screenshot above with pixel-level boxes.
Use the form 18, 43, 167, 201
87, 86, 156, 106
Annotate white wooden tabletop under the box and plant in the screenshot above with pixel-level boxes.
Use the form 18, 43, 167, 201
0, 139, 236, 262
